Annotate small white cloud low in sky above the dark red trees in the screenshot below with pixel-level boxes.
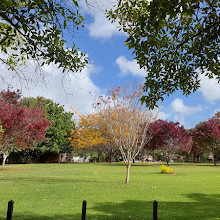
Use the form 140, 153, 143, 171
171, 98, 202, 115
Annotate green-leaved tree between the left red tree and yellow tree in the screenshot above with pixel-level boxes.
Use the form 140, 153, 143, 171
23, 97, 75, 153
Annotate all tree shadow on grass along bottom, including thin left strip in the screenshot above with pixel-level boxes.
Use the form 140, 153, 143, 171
9, 194, 220, 220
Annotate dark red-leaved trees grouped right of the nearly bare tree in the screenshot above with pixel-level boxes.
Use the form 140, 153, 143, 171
145, 113, 220, 165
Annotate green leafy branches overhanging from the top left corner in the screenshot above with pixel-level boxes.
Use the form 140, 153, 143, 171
0, 0, 87, 78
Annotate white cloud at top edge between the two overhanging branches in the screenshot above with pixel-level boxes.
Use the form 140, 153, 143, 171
80, 0, 125, 39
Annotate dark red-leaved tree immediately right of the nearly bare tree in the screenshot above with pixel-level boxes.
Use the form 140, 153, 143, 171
145, 120, 192, 165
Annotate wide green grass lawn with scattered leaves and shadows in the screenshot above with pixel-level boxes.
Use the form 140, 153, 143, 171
0, 163, 220, 220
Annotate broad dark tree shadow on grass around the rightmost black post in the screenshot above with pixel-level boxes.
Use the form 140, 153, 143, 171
90, 194, 220, 220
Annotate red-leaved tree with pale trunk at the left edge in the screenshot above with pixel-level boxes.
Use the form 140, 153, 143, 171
0, 90, 50, 166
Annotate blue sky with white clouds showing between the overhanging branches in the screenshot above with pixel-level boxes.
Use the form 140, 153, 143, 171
0, 0, 220, 128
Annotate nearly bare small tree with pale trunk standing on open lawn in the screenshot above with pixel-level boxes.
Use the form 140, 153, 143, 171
95, 83, 156, 184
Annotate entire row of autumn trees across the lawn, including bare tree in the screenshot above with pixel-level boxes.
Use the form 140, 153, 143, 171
0, 86, 220, 183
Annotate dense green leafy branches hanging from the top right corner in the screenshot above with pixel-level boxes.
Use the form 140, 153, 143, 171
108, 0, 220, 108
